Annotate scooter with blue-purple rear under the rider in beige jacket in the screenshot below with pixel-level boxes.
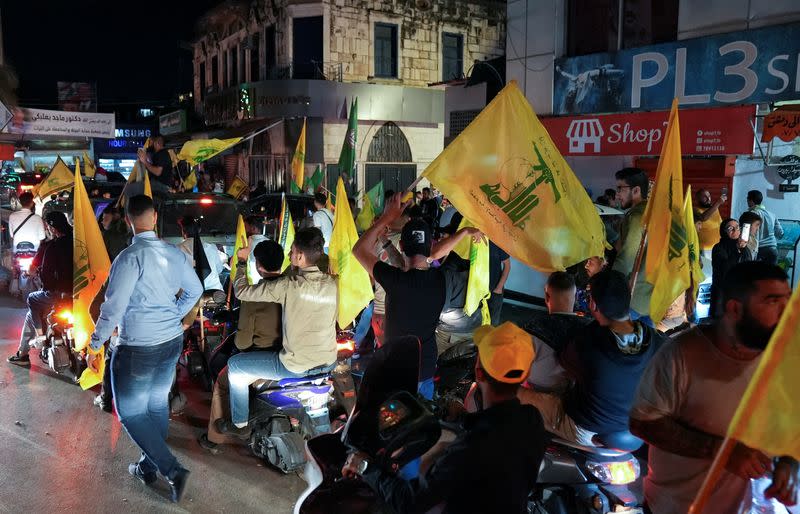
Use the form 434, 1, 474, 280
249, 333, 355, 473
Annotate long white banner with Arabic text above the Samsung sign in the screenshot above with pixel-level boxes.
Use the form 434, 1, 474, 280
8, 108, 115, 139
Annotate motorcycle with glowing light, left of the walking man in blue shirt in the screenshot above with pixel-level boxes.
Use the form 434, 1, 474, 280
34, 294, 86, 384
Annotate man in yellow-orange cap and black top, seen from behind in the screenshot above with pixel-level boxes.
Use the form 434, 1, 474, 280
342, 322, 546, 513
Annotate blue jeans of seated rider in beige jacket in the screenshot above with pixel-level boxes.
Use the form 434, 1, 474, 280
228, 351, 335, 426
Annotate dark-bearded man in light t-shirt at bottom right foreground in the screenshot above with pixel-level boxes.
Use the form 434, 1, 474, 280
630, 262, 797, 514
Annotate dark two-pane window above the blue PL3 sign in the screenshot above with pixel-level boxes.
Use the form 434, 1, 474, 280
567, 0, 680, 56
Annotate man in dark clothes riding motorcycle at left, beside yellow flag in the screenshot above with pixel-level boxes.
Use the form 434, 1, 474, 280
8, 212, 72, 366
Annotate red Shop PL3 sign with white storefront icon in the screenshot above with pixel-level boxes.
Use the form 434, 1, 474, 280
542, 106, 755, 155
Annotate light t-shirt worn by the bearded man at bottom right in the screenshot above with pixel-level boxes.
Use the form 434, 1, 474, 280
631, 329, 760, 514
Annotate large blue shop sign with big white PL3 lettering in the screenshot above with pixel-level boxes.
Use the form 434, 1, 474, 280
553, 24, 800, 114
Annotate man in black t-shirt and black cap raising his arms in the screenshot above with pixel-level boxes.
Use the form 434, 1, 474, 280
353, 193, 446, 398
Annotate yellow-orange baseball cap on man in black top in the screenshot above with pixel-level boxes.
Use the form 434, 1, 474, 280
473, 321, 536, 384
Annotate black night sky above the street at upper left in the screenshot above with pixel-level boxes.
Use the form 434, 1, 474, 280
0, 0, 221, 111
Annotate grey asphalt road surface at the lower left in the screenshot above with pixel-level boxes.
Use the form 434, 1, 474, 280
0, 295, 305, 514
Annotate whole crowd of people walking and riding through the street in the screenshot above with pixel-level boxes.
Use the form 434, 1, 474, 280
8, 158, 798, 514
